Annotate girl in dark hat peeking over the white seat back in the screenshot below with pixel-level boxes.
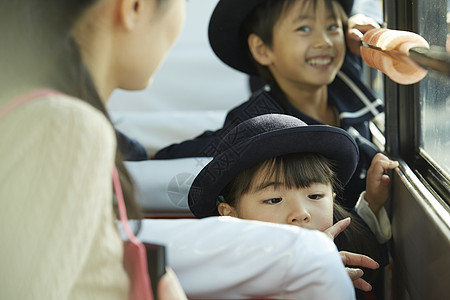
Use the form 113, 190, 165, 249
189, 114, 398, 291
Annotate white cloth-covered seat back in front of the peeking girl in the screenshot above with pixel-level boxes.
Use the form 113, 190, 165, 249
138, 217, 355, 299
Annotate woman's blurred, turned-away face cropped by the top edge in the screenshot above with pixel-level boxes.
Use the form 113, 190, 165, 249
119, 0, 186, 90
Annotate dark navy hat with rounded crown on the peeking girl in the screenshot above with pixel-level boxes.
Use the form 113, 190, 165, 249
188, 114, 359, 218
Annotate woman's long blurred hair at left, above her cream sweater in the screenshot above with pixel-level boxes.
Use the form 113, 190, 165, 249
0, 0, 152, 218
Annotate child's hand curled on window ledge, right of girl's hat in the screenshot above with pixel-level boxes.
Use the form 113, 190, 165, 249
364, 153, 398, 216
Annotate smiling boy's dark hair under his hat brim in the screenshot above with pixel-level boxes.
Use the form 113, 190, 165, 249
240, 0, 347, 88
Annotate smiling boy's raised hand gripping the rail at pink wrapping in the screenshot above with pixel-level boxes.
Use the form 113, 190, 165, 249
346, 14, 380, 55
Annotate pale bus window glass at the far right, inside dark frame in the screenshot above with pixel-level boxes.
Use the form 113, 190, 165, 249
412, 0, 450, 203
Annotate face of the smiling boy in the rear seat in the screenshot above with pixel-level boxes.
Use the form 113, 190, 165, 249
267, 0, 345, 87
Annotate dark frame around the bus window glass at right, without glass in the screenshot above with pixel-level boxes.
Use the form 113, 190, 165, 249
383, 0, 450, 205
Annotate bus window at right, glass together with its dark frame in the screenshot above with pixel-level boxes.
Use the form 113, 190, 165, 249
383, 0, 450, 205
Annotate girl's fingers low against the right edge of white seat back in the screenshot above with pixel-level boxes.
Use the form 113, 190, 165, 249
339, 251, 380, 292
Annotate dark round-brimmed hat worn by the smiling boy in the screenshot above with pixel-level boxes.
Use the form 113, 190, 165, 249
208, 0, 353, 75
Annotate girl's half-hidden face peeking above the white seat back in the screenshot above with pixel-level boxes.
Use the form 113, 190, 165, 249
218, 168, 335, 231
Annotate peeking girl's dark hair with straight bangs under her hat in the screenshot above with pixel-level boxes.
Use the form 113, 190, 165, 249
218, 153, 380, 266
